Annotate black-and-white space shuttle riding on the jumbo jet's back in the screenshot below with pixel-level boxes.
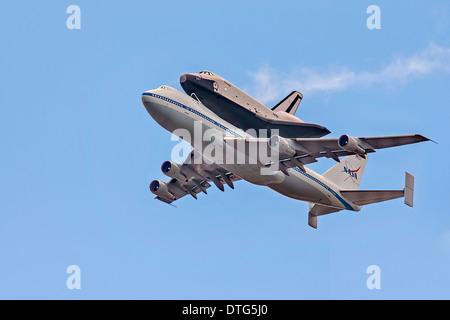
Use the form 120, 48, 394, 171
180, 71, 330, 138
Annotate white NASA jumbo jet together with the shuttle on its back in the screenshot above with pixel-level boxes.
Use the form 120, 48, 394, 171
142, 71, 429, 228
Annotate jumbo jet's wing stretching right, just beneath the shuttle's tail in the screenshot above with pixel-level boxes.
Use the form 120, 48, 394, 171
225, 134, 430, 172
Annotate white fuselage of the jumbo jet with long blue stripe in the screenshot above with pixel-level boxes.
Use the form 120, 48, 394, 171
142, 86, 360, 211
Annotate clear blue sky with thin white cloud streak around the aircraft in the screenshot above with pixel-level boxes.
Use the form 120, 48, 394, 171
0, 1, 450, 299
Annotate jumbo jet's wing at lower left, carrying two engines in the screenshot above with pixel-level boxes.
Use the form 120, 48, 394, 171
155, 150, 241, 204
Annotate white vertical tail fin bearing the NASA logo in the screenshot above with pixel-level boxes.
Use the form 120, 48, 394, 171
322, 155, 367, 190
